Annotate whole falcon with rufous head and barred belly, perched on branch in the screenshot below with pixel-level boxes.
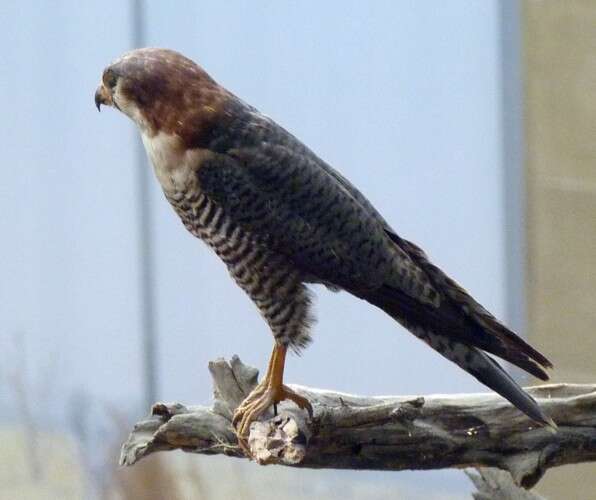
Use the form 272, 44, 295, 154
95, 48, 555, 454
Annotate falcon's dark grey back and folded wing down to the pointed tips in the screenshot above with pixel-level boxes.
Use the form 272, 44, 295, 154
198, 110, 552, 379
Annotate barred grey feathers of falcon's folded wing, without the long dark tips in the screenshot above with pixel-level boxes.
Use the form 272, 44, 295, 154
197, 143, 439, 305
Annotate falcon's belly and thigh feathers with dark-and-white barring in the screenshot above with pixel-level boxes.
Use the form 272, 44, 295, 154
166, 191, 313, 351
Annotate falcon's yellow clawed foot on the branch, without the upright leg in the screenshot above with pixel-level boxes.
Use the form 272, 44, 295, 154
232, 379, 313, 457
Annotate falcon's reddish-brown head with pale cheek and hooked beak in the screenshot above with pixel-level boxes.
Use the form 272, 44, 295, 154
95, 48, 230, 143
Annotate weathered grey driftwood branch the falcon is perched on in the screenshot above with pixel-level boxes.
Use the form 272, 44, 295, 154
120, 357, 596, 487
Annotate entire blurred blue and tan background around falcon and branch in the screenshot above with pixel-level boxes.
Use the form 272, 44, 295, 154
0, 0, 596, 500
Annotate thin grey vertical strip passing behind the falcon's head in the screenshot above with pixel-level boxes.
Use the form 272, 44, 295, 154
132, 0, 158, 408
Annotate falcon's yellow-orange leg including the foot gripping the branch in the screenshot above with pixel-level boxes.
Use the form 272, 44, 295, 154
232, 344, 313, 455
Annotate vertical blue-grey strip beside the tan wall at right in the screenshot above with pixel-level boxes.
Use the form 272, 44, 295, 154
497, 0, 527, 376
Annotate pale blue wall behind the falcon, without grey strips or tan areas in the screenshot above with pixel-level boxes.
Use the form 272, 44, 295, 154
0, 0, 520, 498
